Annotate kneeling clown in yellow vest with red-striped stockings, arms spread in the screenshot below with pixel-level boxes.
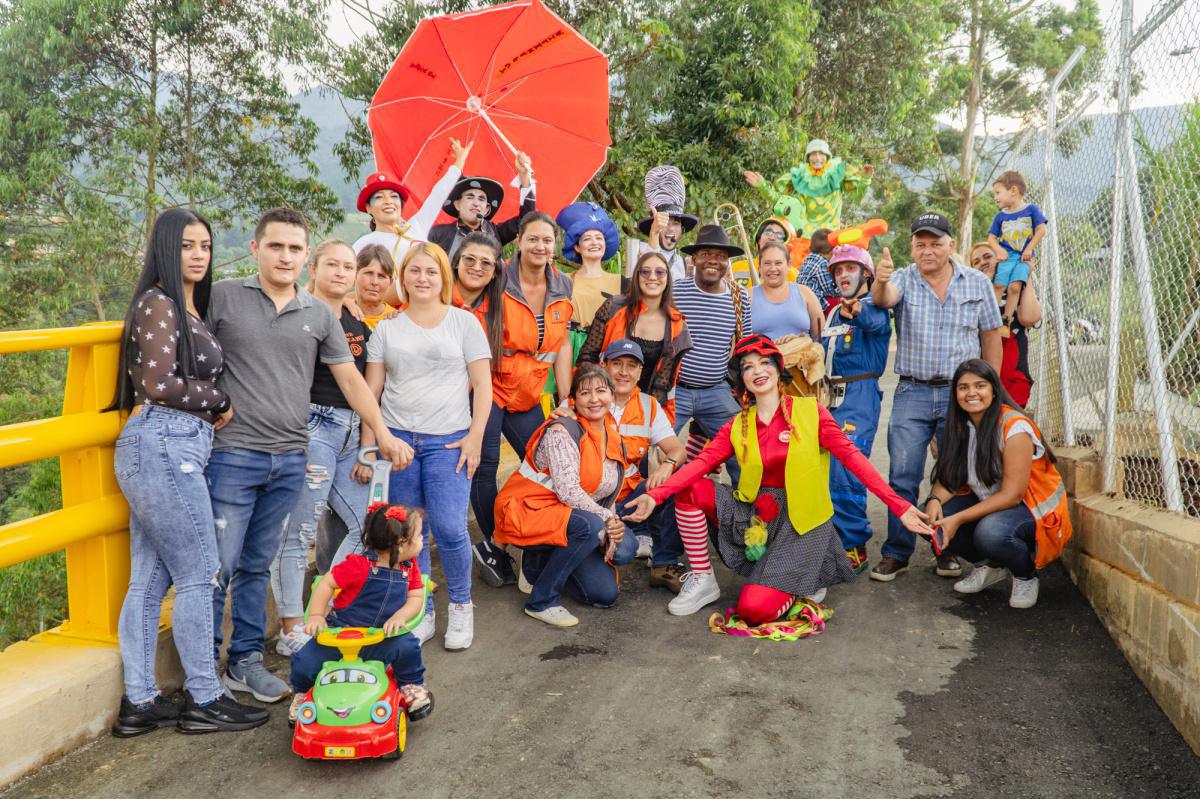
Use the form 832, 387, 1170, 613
625, 334, 932, 626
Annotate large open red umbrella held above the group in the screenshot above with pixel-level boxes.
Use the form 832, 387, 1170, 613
367, 0, 612, 220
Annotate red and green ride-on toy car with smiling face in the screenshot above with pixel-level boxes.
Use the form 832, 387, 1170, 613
292, 627, 408, 759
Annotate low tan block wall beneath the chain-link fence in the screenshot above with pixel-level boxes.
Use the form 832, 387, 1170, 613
1056, 447, 1200, 755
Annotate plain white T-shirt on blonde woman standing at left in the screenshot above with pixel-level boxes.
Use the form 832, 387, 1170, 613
367, 303, 492, 435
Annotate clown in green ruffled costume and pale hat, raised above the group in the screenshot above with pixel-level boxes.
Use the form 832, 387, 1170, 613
743, 139, 875, 260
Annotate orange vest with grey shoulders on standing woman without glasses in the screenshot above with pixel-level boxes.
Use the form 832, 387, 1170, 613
492, 258, 574, 413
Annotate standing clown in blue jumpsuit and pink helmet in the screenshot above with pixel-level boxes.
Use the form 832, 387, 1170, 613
823, 245, 892, 572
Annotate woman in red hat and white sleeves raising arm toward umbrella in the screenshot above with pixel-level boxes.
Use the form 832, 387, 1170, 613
354, 139, 472, 305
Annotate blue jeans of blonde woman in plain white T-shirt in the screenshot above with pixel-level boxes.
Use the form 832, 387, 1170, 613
388, 429, 472, 612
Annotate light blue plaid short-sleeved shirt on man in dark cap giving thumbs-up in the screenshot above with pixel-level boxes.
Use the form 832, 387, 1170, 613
892, 262, 1000, 380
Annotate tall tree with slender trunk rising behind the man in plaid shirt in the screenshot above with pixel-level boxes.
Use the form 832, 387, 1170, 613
931, 0, 1103, 248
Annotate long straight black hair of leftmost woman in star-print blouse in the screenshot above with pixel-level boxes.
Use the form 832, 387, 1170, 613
104, 208, 212, 410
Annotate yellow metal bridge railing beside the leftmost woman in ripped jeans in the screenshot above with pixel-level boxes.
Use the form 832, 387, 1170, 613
0, 322, 130, 644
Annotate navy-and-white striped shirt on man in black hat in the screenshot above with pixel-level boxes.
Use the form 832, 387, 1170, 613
674, 277, 754, 389
